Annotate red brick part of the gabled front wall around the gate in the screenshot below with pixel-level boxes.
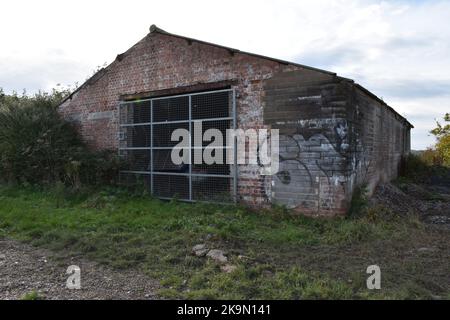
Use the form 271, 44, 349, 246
60, 33, 299, 204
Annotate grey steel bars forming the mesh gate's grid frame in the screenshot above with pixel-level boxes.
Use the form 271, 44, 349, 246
118, 89, 238, 203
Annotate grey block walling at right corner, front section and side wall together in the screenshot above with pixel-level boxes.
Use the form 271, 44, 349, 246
264, 70, 410, 216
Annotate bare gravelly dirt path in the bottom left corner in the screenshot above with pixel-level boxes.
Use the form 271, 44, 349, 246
0, 239, 158, 300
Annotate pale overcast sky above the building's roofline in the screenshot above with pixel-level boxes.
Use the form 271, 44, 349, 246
0, 0, 450, 149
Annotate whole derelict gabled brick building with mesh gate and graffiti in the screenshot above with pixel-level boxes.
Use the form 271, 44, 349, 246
59, 26, 412, 215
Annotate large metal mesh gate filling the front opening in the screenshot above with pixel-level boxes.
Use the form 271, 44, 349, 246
119, 89, 237, 202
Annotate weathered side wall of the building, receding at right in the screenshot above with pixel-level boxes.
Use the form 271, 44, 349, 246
348, 87, 411, 193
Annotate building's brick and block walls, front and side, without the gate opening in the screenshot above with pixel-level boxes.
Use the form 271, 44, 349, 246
60, 27, 409, 215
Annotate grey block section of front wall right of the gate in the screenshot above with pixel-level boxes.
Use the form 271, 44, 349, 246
264, 71, 351, 216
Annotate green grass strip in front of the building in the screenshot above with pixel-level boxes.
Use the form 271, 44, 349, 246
0, 187, 449, 299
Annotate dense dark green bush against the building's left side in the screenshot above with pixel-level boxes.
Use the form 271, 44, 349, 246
0, 90, 119, 188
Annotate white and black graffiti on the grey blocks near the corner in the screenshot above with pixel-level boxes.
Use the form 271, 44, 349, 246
265, 120, 370, 210
